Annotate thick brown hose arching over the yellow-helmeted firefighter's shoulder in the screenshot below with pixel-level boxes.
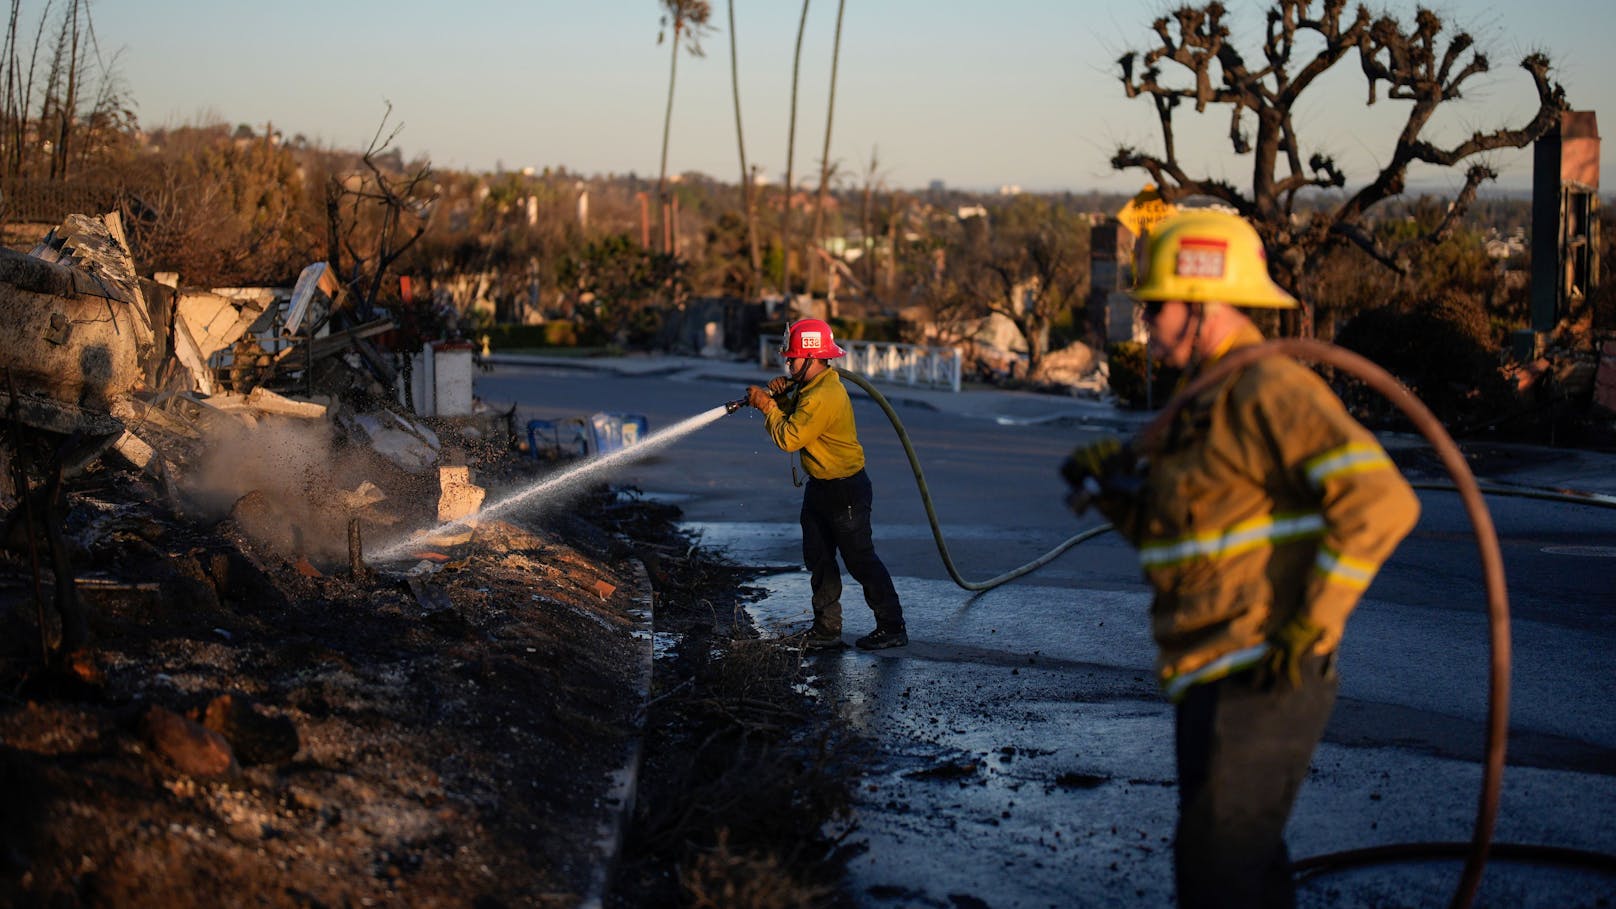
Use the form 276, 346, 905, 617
1133, 338, 1509, 909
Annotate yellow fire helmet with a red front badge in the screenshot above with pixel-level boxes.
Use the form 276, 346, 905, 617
1133, 210, 1296, 309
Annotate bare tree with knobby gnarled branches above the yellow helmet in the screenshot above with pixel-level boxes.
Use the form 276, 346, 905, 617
1112, 0, 1564, 333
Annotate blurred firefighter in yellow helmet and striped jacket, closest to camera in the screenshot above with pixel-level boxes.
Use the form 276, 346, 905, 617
1062, 212, 1419, 907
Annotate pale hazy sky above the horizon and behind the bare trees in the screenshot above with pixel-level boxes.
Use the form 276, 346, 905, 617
94, 0, 1616, 191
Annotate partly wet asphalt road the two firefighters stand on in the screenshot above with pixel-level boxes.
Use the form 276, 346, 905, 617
478, 360, 1616, 907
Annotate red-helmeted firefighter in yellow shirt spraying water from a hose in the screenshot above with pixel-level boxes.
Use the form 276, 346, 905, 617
747, 319, 908, 650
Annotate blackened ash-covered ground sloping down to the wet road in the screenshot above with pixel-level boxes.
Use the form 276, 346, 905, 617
0, 420, 858, 907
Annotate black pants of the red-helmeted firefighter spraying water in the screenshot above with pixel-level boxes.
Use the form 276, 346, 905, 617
802, 471, 903, 632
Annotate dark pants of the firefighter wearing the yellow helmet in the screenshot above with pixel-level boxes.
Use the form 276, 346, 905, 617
1173, 653, 1336, 909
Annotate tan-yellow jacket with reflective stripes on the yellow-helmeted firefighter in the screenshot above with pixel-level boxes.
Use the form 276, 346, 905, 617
1097, 321, 1419, 700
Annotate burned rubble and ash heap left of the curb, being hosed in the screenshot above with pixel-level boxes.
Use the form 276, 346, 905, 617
0, 215, 662, 906
